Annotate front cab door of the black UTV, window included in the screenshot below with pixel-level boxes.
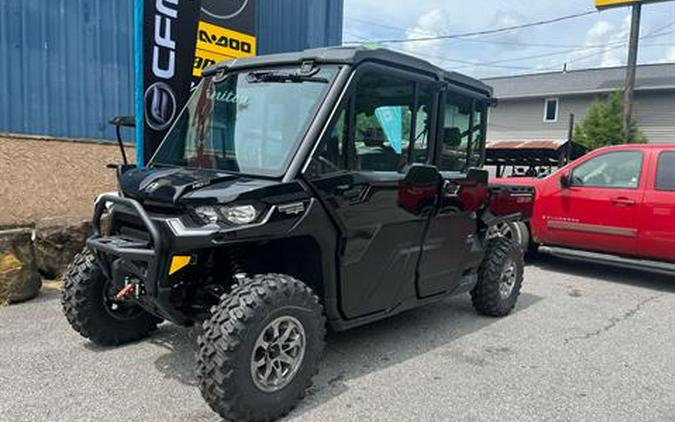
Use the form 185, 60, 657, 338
306, 64, 440, 319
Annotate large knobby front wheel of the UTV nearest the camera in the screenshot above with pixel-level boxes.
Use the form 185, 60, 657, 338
197, 274, 326, 422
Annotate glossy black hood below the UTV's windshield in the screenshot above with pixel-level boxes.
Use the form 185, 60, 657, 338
120, 168, 238, 203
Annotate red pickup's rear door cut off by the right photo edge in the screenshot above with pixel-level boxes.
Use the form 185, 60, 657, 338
638, 150, 675, 261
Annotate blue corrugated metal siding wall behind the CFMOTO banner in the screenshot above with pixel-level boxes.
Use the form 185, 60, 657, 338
0, 0, 343, 139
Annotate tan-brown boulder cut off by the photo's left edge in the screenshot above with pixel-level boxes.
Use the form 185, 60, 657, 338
0, 229, 42, 304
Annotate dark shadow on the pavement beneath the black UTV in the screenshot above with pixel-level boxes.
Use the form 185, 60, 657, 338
135, 293, 541, 416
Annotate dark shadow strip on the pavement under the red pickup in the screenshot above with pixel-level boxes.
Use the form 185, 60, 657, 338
527, 254, 675, 293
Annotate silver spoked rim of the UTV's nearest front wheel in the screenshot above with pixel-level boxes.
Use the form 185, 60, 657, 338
251, 316, 307, 393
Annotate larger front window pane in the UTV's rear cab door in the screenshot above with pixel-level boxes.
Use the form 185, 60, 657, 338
440, 94, 473, 171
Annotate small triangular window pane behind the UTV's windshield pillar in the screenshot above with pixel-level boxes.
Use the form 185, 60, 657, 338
309, 108, 347, 177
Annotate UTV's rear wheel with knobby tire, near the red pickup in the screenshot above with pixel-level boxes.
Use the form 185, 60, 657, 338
471, 236, 525, 317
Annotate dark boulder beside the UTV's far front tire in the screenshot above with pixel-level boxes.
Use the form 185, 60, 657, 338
35, 218, 91, 279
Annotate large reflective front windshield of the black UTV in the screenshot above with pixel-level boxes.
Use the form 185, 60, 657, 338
150, 66, 338, 177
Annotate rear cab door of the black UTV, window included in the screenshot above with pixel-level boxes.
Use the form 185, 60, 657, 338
417, 91, 488, 298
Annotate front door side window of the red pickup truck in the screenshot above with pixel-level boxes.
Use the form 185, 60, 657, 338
572, 151, 642, 189
